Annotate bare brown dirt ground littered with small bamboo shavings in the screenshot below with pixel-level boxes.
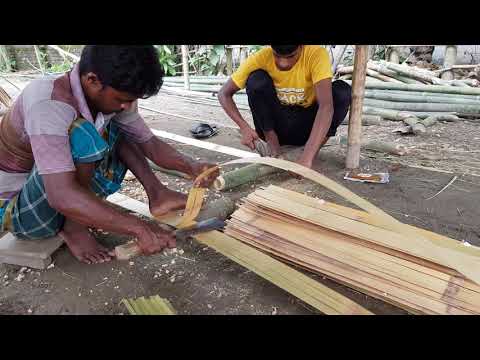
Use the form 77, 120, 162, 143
0, 76, 480, 314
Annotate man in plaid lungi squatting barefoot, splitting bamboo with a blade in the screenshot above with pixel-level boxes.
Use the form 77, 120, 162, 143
0, 45, 217, 263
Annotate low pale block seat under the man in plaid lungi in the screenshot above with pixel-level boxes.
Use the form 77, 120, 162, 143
0, 233, 63, 269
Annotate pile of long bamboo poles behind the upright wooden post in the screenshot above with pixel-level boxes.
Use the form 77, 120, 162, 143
337, 61, 480, 134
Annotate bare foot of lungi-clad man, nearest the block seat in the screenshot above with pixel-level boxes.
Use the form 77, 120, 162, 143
59, 219, 111, 264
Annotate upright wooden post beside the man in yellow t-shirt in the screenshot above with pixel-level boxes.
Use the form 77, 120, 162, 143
346, 45, 368, 170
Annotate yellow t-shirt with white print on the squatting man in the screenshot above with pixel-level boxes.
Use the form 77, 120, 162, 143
232, 45, 333, 107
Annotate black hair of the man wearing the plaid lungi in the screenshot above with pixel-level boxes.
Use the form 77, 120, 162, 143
79, 45, 164, 99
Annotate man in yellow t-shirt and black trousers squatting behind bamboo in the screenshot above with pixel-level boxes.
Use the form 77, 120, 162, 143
218, 45, 351, 168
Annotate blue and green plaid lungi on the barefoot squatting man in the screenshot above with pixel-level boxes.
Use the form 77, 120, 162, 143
0, 119, 127, 240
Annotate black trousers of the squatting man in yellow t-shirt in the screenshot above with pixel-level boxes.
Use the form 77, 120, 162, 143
246, 70, 352, 146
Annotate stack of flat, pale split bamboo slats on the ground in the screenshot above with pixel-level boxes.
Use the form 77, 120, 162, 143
226, 185, 480, 314
